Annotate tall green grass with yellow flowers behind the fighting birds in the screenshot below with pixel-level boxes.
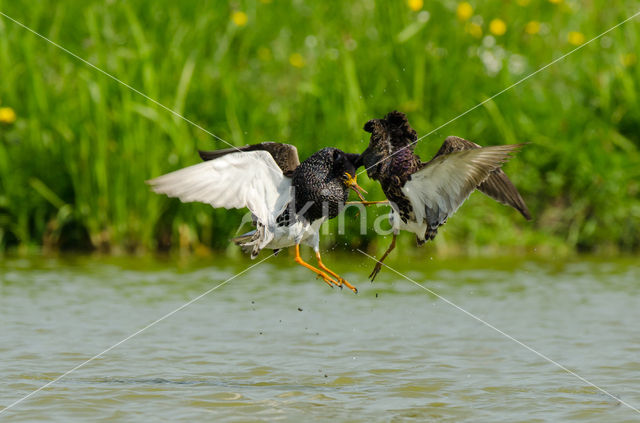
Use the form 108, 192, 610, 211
0, 0, 640, 254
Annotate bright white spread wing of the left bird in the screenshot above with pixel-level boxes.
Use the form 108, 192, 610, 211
147, 151, 291, 224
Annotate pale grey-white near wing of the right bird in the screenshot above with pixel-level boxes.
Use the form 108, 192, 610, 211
402, 145, 520, 232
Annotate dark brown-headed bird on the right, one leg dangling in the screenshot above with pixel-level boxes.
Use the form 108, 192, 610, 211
356, 111, 531, 281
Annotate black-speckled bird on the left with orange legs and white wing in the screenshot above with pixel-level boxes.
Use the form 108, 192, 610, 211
147, 142, 366, 293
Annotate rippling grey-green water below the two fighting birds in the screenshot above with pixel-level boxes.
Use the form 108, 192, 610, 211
0, 254, 640, 422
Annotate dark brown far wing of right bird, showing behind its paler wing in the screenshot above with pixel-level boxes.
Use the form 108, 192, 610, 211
432, 136, 531, 220
